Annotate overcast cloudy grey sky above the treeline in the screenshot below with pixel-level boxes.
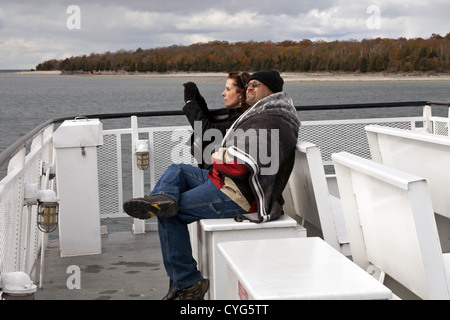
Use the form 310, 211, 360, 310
0, 0, 450, 69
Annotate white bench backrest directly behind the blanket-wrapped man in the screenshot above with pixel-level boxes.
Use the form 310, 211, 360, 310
288, 141, 351, 256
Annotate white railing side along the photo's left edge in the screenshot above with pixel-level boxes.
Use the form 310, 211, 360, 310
0, 125, 53, 274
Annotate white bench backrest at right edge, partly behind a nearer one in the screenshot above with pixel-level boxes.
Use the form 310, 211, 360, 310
366, 125, 450, 252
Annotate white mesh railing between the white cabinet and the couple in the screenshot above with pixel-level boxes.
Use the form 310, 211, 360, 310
98, 127, 197, 218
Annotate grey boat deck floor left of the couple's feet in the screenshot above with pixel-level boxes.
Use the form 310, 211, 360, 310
35, 218, 169, 300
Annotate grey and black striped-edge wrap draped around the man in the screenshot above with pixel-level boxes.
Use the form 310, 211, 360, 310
222, 92, 300, 222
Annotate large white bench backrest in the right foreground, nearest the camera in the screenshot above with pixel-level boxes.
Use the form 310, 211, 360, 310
332, 152, 450, 299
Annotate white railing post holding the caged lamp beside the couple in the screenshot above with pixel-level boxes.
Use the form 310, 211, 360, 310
131, 116, 145, 234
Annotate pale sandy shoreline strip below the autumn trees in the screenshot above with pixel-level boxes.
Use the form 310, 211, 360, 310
15, 71, 450, 82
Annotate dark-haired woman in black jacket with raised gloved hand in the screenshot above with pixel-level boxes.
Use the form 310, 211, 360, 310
183, 72, 250, 169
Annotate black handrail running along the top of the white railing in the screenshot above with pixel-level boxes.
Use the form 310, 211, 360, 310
0, 101, 450, 169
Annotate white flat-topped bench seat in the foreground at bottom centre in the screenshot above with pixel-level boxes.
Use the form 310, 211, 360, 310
218, 237, 392, 300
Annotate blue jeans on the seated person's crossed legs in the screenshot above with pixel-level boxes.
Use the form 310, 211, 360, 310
150, 164, 246, 291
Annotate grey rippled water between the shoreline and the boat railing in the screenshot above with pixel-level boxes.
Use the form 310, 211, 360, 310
0, 73, 450, 151
